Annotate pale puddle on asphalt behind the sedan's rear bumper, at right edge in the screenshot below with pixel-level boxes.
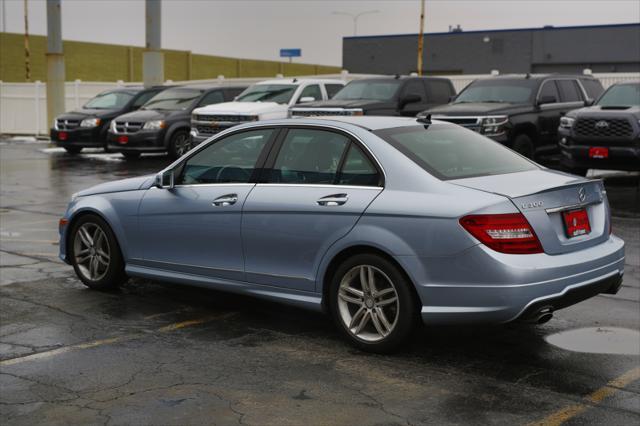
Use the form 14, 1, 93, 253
546, 327, 640, 355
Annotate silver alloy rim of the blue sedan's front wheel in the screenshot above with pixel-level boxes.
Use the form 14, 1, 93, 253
73, 222, 111, 281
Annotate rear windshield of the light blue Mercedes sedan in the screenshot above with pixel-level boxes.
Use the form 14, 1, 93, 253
375, 124, 537, 180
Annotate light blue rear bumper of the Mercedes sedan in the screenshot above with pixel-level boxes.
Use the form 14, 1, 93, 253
396, 236, 624, 324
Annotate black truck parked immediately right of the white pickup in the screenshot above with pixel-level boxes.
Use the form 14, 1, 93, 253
289, 76, 456, 117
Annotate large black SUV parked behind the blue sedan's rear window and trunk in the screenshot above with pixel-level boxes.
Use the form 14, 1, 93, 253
418, 75, 604, 158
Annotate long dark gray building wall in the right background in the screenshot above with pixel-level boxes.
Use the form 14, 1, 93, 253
342, 24, 640, 74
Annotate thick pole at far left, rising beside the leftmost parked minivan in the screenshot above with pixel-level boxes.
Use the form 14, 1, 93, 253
45, 0, 65, 132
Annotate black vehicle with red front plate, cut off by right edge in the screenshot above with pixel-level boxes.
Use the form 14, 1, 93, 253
558, 82, 640, 176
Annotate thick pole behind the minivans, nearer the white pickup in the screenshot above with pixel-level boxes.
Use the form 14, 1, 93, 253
142, 0, 164, 87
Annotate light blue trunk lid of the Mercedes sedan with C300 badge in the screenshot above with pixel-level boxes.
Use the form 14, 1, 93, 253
449, 169, 610, 254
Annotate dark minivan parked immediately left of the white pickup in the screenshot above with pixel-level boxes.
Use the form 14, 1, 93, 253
107, 86, 247, 159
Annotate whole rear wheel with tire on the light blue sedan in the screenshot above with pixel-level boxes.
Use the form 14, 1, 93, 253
329, 254, 418, 353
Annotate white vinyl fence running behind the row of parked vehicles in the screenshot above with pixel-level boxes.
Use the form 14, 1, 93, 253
0, 71, 640, 136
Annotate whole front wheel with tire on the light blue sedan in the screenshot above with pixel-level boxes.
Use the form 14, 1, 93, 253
69, 214, 127, 290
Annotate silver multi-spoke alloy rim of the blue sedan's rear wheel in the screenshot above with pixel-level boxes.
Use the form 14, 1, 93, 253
338, 265, 400, 342
